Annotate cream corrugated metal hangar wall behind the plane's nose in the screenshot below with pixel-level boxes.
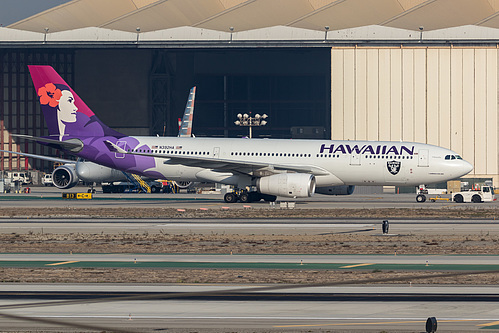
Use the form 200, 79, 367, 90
331, 47, 499, 185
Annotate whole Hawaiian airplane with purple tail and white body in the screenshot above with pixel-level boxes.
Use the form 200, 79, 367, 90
19, 66, 473, 203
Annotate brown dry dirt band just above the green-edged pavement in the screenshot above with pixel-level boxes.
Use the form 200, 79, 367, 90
0, 232, 499, 254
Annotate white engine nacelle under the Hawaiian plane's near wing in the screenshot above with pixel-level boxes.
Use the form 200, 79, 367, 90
256, 173, 315, 198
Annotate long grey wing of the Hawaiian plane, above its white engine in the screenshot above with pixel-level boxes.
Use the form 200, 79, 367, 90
105, 140, 331, 176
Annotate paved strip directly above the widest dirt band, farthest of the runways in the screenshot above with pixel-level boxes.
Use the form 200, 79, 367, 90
0, 217, 499, 238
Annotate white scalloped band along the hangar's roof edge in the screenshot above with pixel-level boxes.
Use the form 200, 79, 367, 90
0, 25, 499, 47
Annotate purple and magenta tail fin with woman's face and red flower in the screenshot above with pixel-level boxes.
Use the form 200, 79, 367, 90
28, 66, 123, 141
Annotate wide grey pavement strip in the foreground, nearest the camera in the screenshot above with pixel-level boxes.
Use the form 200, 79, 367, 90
0, 284, 499, 332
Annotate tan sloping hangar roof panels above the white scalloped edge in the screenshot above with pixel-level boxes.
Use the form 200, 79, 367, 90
8, 0, 499, 33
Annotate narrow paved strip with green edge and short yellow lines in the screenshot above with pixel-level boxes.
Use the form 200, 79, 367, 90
0, 253, 499, 275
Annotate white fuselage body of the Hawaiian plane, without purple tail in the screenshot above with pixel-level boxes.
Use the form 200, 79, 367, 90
115, 137, 473, 187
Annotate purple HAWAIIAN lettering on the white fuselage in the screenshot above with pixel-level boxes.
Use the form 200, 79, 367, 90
319, 144, 414, 156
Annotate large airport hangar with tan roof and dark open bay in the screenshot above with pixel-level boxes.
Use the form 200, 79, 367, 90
0, 0, 499, 187
